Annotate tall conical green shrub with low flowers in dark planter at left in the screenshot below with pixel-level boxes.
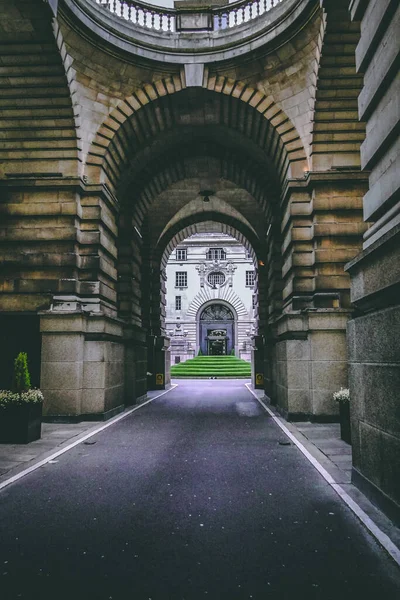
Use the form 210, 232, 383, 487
0, 352, 43, 444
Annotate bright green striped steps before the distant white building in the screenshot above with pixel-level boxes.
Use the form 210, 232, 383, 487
171, 356, 251, 378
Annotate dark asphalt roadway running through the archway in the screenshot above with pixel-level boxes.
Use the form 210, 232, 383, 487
0, 380, 400, 600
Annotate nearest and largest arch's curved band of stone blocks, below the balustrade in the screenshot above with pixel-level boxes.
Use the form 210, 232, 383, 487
87, 77, 308, 185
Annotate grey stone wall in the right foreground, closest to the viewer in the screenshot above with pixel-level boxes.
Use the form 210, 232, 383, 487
347, 0, 400, 517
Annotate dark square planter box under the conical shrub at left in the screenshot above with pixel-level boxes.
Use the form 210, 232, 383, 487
0, 402, 43, 444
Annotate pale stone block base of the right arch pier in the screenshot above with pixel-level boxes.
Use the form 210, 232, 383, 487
268, 309, 350, 422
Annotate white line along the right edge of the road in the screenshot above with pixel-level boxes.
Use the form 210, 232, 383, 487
245, 383, 400, 566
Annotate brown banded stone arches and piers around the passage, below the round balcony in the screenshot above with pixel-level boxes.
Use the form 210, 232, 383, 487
0, 0, 366, 432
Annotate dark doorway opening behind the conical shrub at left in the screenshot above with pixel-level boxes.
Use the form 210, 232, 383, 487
0, 313, 41, 389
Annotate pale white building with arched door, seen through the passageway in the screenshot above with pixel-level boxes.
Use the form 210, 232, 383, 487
166, 233, 257, 364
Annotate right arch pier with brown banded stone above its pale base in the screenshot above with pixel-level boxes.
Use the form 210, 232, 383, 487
269, 171, 367, 421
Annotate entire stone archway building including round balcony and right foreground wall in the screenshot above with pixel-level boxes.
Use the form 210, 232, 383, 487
0, 0, 400, 511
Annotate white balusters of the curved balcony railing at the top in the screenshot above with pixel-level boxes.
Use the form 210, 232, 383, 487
95, 0, 284, 32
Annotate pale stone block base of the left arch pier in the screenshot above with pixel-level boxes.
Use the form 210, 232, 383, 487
40, 311, 146, 420
